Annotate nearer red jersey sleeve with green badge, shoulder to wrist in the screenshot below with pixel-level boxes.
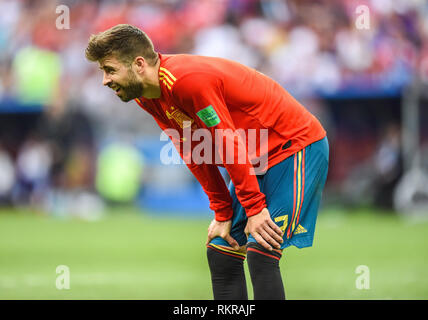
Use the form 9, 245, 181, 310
173, 73, 266, 217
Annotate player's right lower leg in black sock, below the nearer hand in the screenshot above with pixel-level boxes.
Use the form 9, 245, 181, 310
247, 242, 285, 300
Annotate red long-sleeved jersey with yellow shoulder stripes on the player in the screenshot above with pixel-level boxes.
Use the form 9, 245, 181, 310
135, 54, 326, 221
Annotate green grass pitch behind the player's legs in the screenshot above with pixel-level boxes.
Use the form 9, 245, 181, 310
0, 209, 428, 300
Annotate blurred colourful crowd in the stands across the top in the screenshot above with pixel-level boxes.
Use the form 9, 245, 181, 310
0, 0, 428, 105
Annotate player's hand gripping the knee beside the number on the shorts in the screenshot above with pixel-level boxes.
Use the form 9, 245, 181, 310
245, 208, 283, 250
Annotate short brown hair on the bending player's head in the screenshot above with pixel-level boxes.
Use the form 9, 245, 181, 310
85, 24, 158, 64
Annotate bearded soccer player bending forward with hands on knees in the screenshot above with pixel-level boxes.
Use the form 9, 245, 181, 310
86, 24, 329, 299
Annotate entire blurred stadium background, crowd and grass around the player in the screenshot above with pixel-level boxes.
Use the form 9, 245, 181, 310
0, 0, 428, 299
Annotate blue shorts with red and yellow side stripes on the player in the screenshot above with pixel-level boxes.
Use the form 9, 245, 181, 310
211, 137, 329, 249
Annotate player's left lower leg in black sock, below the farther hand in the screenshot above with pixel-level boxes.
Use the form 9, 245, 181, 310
207, 245, 248, 300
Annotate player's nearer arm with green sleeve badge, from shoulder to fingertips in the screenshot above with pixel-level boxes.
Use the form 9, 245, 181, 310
173, 74, 282, 250
